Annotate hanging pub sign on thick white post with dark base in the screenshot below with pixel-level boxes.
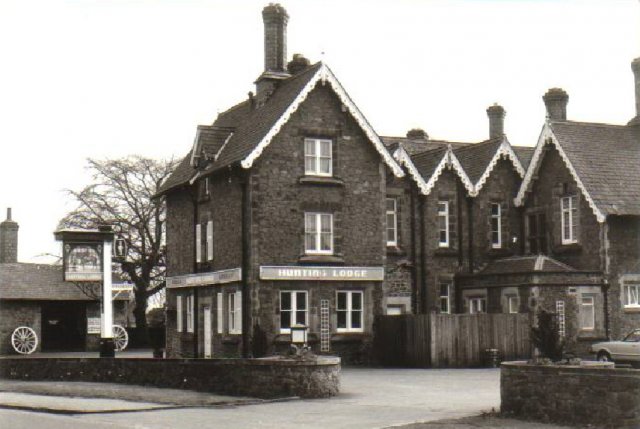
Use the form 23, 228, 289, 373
54, 225, 115, 357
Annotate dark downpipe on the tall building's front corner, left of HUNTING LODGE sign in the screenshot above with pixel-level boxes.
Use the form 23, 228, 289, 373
241, 170, 251, 358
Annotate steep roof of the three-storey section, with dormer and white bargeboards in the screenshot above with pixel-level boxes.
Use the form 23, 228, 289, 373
157, 62, 404, 195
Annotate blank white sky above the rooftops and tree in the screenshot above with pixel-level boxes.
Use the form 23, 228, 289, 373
0, 0, 640, 262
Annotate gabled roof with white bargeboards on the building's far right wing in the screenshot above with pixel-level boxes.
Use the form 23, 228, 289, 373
515, 121, 640, 222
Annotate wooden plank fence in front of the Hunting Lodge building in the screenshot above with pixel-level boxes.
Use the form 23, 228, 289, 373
373, 313, 531, 368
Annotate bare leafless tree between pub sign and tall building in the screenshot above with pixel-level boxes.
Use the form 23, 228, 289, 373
59, 156, 175, 328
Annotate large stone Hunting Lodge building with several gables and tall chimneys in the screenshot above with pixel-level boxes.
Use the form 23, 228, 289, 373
158, 4, 640, 361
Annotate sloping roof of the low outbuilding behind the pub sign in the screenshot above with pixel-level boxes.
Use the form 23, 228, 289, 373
0, 262, 128, 301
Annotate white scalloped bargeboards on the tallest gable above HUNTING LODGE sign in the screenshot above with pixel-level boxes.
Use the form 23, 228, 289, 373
240, 63, 405, 177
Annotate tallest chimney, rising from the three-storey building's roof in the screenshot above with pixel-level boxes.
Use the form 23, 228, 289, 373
256, 3, 291, 104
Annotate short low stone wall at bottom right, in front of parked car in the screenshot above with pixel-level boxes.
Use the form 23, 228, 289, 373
500, 362, 640, 427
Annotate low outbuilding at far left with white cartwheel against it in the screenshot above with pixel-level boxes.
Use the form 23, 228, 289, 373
0, 209, 129, 354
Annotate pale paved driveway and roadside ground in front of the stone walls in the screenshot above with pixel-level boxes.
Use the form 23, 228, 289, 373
0, 367, 576, 429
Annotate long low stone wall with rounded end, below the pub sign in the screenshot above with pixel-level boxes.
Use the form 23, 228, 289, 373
0, 357, 340, 399
